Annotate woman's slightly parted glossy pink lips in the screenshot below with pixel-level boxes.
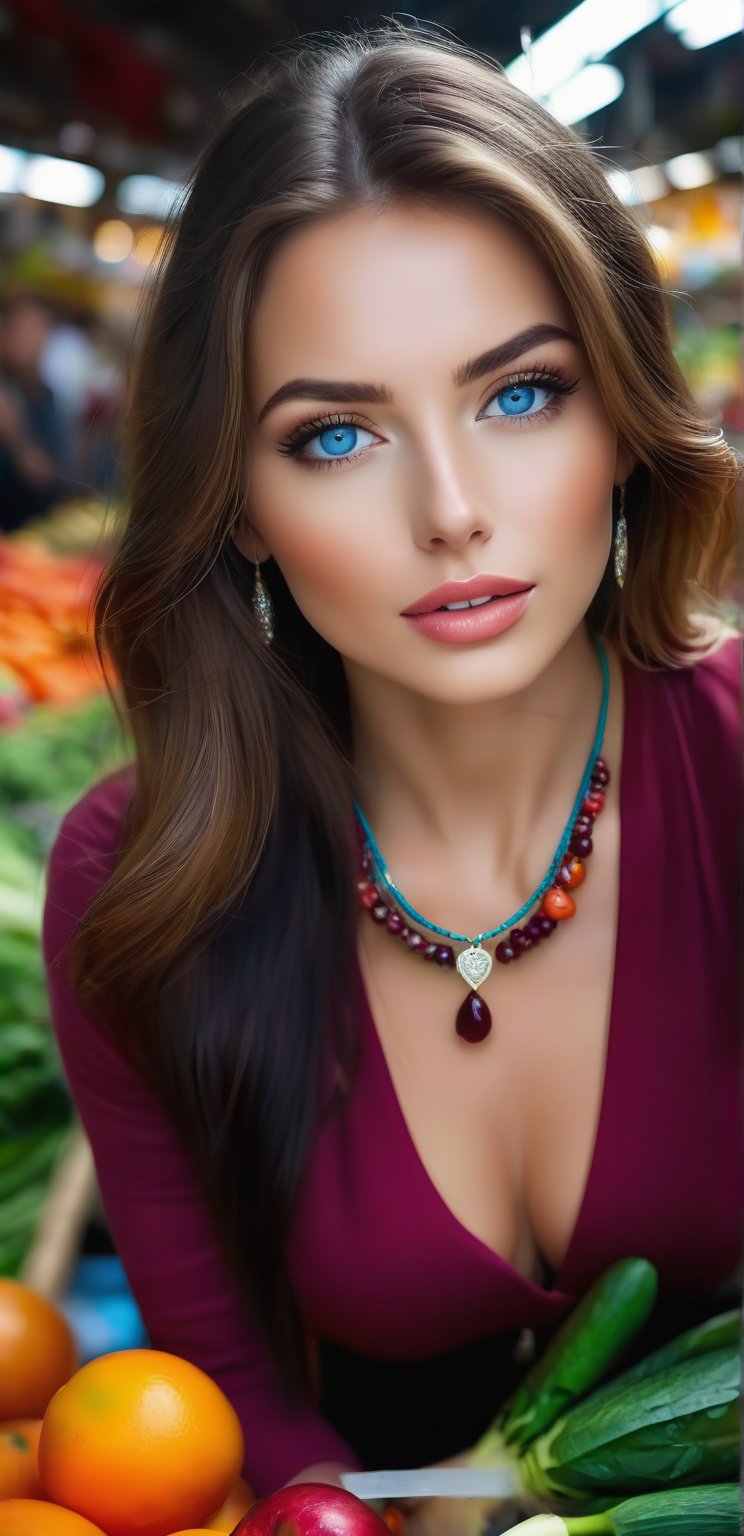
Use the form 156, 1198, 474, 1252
403, 574, 535, 645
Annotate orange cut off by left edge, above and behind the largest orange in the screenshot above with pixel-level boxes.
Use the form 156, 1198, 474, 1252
0, 1278, 77, 1419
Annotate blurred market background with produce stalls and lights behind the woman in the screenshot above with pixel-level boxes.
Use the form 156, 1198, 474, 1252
0, 0, 744, 1358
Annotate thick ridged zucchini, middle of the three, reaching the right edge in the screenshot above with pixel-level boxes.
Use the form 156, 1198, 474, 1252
520, 1346, 739, 1501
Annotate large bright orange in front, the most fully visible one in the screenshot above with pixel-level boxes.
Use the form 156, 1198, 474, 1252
38, 1349, 243, 1536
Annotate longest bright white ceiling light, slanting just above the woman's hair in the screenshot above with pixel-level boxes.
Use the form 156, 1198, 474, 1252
506, 0, 672, 97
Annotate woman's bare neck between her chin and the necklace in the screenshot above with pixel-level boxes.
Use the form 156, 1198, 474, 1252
347, 627, 603, 905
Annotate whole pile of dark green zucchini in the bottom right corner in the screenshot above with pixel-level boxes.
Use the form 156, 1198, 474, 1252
469, 1258, 741, 1536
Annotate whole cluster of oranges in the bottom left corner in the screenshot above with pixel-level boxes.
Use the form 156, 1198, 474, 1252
0, 1281, 253, 1536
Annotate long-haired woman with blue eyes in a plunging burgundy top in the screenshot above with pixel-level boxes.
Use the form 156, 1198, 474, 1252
46, 23, 742, 1511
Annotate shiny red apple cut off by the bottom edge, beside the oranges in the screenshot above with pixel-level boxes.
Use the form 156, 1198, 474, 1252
232, 1482, 389, 1536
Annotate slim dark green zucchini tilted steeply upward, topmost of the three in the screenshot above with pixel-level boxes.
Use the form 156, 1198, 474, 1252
470, 1258, 658, 1465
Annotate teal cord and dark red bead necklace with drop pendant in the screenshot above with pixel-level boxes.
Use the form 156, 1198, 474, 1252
354, 639, 610, 1044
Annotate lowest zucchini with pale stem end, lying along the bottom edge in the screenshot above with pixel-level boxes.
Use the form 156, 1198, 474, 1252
494, 1482, 741, 1536
